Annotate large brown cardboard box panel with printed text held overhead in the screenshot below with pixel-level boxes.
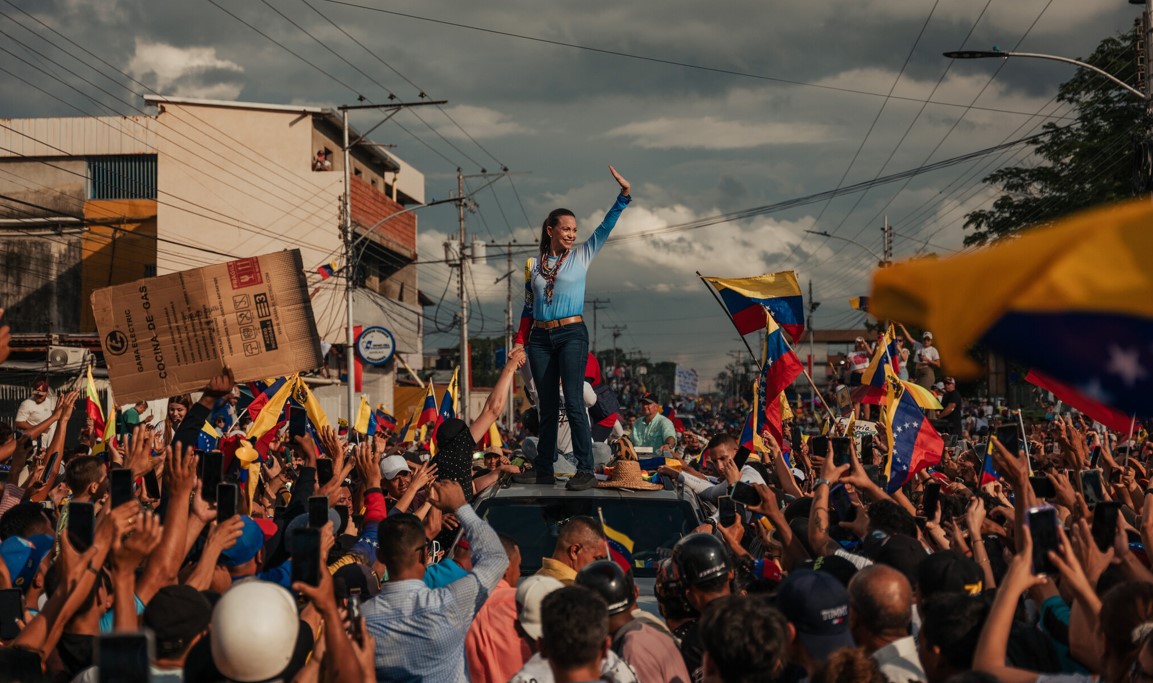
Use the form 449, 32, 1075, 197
92, 249, 322, 404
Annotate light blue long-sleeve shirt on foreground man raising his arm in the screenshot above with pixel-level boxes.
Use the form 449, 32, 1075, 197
362, 505, 508, 683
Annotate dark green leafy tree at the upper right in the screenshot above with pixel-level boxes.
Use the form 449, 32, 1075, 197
965, 31, 1148, 246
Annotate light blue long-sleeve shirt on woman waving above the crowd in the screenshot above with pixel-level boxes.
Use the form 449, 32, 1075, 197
521, 195, 632, 321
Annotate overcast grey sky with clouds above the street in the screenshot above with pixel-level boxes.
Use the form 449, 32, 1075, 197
0, 0, 1140, 392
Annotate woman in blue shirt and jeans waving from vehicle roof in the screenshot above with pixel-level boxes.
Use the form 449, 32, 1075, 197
513, 166, 632, 490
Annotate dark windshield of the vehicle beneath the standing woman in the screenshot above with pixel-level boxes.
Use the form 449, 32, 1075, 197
480, 497, 698, 578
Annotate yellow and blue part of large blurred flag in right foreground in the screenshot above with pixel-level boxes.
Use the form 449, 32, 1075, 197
872, 197, 1153, 416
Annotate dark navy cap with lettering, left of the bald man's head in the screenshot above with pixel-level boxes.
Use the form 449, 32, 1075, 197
777, 569, 853, 661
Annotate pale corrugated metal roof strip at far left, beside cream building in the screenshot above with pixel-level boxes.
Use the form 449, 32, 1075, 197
0, 117, 157, 158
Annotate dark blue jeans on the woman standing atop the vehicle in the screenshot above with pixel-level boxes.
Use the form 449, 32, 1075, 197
525, 323, 593, 474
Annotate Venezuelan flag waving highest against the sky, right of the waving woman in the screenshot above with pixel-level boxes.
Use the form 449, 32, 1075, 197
701, 270, 805, 339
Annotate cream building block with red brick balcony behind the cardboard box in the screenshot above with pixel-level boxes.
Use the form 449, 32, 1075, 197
0, 96, 424, 415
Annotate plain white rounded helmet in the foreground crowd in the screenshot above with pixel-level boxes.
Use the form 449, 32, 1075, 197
212, 580, 300, 681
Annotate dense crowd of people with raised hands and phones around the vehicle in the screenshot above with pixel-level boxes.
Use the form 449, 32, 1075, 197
0, 295, 1153, 683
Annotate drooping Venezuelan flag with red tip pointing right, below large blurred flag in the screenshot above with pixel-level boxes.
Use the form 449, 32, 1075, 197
884, 382, 944, 494
